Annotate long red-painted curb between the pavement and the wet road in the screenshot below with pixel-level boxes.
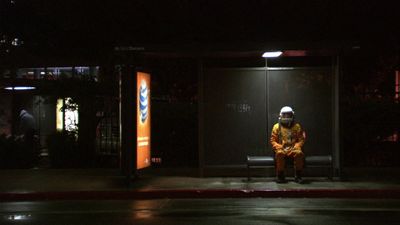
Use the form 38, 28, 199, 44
0, 189, 400, 202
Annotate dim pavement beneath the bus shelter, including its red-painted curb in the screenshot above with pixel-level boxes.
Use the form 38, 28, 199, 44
0, 169, 400, 201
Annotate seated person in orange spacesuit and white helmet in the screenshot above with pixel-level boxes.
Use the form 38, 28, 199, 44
271, 106, 304, 183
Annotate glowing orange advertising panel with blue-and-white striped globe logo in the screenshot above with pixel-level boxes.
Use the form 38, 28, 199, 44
136, 72, 151, 169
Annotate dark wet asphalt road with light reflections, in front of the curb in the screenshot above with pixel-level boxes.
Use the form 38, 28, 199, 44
0, 198, 400, 225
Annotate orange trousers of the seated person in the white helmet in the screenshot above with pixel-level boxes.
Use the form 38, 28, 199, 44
275, 150, 304, 173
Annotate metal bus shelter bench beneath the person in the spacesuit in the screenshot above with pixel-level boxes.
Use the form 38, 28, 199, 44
247, 155, 333, 181
